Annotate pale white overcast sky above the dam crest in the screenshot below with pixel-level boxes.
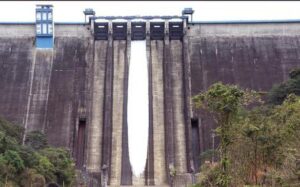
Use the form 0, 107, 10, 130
0, 1, 300, 22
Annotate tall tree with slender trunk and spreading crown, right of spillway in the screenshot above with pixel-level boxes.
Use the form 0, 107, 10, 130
193, 83, 244, 186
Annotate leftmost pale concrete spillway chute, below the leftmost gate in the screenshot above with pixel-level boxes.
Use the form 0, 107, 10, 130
87, 40, 108, 173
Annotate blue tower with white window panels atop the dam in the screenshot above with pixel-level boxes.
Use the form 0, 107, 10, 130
35, 5, 54, 48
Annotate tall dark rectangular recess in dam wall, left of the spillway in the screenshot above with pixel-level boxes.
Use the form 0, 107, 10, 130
76, 118, 86, 168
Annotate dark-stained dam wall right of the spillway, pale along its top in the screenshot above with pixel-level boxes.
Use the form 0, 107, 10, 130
188, 23, 300, 169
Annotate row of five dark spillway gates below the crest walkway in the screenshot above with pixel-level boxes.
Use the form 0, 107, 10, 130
90, 16, 187, 40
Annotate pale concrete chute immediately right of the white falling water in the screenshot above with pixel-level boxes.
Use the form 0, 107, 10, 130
149, 41, 167, 185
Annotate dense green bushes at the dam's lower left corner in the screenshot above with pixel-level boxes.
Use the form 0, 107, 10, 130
0, 118, 75, 187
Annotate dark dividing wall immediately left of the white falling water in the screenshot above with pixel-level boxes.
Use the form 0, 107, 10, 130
121, 21, 132, 185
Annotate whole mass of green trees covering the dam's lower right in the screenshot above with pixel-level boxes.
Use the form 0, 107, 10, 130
194, 83, 300, 187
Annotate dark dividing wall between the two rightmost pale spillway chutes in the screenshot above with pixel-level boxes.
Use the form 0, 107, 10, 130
163, 21, 175, 183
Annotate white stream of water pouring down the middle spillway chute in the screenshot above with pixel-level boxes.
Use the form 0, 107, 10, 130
127, 41, 149, 176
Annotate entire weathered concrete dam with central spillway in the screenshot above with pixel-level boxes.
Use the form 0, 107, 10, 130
0, 5, 300, 186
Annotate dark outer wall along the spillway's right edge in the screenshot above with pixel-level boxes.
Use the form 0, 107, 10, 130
182, 20, 195, 172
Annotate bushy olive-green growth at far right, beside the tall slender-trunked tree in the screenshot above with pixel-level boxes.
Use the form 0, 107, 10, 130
229, 95, 300, 186
